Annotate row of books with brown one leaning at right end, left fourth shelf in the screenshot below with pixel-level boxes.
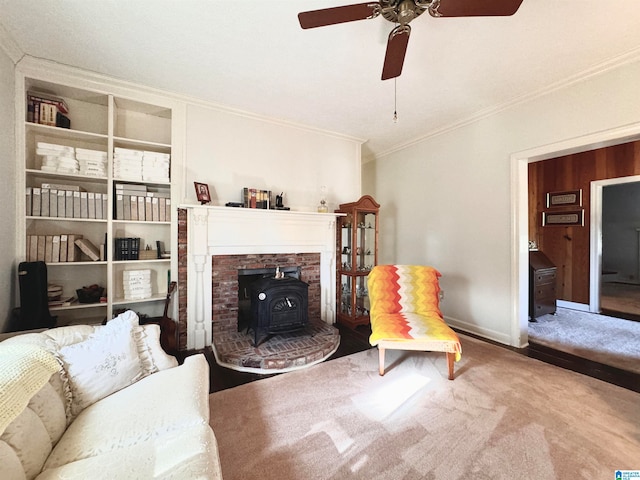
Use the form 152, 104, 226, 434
26, 234, 106, 263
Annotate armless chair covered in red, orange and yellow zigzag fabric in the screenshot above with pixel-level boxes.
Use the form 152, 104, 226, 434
367, 265, 462, 380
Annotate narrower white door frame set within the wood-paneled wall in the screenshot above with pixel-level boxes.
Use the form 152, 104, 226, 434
589, 175, 640, 313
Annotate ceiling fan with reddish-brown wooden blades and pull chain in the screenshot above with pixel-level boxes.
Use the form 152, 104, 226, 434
298, 0, 523, 80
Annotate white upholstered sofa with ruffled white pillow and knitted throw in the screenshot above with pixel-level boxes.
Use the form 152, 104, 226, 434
0, 312, 222, 480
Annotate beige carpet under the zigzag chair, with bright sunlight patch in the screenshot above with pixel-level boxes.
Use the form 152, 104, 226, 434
210, 336, 640, 480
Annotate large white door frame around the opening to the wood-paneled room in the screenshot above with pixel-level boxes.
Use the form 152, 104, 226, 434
511, 123, 640, 347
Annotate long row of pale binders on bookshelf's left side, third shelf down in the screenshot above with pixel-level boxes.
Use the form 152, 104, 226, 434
25, 183, 108, 220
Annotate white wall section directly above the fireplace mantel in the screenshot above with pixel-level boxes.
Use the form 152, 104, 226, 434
183, 105, 361, 211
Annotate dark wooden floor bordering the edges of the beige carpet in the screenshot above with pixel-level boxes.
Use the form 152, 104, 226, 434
196, 324, 640, 393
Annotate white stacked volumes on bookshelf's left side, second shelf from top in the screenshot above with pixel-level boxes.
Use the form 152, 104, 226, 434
36, 142, 107, 178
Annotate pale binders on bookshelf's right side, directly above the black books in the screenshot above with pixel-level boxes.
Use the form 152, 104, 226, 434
114, 183, 171, 222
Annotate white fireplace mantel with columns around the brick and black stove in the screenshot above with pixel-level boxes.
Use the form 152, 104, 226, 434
180, 205, 342, 350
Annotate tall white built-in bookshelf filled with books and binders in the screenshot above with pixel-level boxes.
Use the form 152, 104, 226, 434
16, 69, 177, 325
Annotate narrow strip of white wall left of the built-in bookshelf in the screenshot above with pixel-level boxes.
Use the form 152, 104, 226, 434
0, 48, 17, 332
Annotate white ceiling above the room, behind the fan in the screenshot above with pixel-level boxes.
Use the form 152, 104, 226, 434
0, 0, 640, 156
